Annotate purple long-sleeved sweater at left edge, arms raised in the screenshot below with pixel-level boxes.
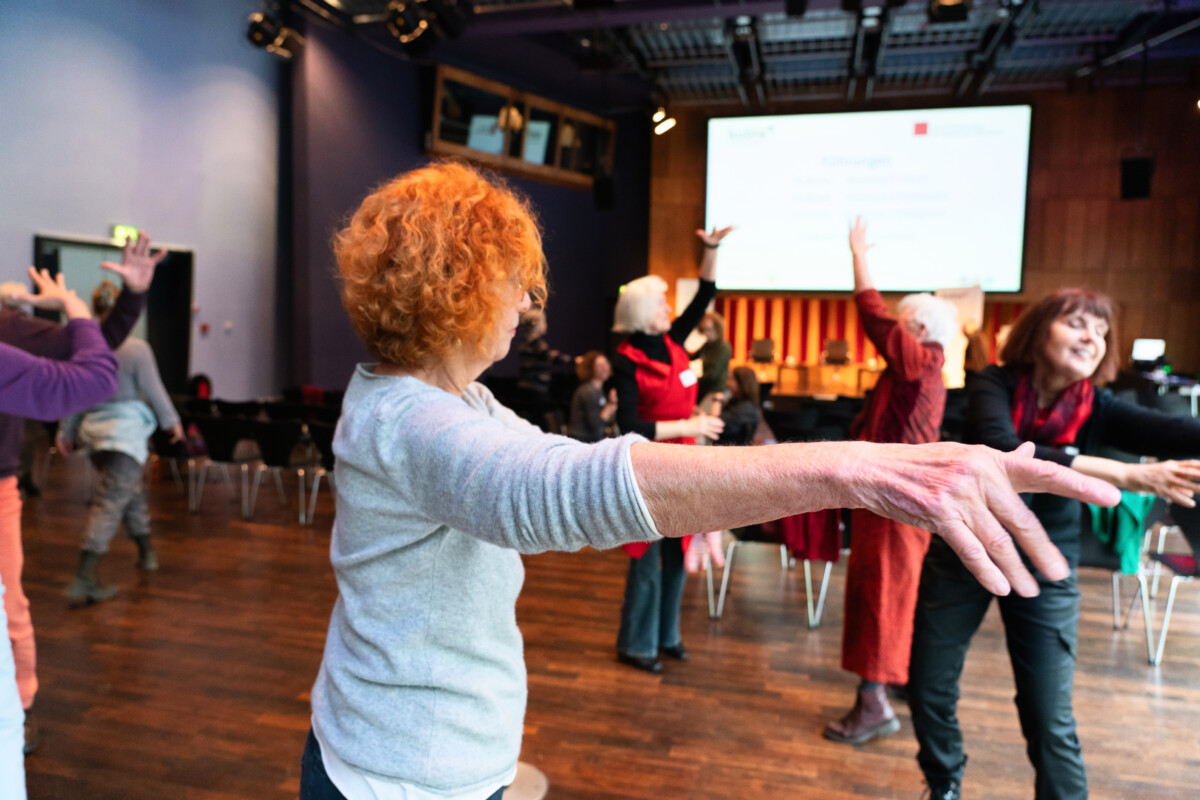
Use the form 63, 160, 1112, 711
0, 291, 145, 477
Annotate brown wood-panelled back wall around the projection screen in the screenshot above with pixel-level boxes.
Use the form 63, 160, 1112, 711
649, 86, 1200, 372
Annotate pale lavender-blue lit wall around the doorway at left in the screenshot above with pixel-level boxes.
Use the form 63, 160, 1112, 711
0, 0, 280, 399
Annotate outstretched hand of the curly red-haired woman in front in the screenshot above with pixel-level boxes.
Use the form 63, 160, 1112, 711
858, 443, 1121, 597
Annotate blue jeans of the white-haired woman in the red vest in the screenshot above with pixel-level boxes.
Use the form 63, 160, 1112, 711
617, 539, 686, 658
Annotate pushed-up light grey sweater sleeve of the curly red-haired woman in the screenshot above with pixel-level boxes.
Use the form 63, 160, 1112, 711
371, 390, 659, 553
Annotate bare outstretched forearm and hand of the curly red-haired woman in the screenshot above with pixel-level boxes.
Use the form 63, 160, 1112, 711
630, 441, 1120, 596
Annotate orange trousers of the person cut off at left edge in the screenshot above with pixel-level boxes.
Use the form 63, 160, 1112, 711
0, 477, 37, 709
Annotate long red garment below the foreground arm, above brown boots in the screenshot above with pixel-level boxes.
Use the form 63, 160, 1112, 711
840, 509, 931, 684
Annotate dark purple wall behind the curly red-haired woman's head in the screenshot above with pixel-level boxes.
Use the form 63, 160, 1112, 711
293, 25, 650, 386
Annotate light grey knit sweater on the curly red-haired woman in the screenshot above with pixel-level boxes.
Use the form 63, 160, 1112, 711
312, 365, 658, 792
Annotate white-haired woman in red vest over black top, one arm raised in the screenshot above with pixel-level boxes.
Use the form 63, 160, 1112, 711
612, 228, 733, 673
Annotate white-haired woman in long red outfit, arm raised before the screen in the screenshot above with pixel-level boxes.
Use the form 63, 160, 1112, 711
824, 218, 958, 744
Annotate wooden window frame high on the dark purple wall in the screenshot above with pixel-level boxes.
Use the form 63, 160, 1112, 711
426, 65, 617, 191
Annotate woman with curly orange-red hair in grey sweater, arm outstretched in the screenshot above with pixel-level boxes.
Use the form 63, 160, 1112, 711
300, 163, 1115, 800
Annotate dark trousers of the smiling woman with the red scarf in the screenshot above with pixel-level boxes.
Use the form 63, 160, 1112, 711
908, 537, 1087, 800
